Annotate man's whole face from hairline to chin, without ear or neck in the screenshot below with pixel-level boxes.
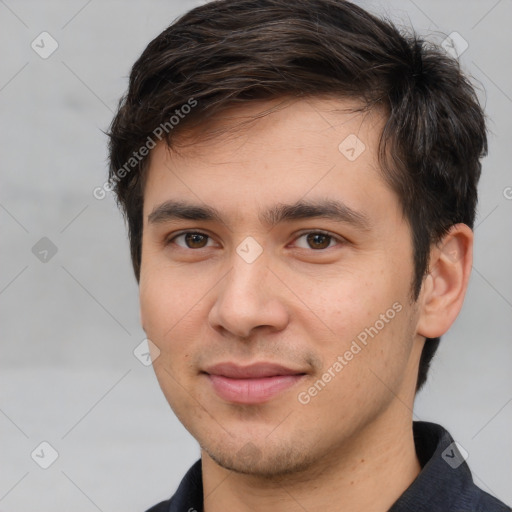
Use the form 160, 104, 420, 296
140, 99, 419, 476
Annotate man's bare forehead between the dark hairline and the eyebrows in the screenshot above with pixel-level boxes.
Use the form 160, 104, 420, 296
144, 98, 390, 218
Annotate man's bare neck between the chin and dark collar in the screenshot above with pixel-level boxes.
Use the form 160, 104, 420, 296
202, 408, 421, 512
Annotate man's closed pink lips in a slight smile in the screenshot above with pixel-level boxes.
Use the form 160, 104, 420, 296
203, 363, 306, 404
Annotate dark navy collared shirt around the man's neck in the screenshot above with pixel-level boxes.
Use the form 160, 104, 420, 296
147, 421, 512, 512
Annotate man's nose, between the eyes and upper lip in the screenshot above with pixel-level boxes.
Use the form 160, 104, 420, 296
208, 249, 289, 338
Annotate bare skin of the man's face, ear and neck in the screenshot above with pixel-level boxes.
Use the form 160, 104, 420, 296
140, 98, 472, 512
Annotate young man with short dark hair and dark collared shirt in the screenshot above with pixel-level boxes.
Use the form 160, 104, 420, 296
110, 0, 509, 512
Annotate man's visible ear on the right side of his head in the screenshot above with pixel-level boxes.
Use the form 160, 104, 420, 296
417, 224, 473, 338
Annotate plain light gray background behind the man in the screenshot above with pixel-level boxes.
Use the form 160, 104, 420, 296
0, 0, 512, 512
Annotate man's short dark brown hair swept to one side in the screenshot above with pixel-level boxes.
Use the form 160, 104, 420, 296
109, 0, 487, 390
